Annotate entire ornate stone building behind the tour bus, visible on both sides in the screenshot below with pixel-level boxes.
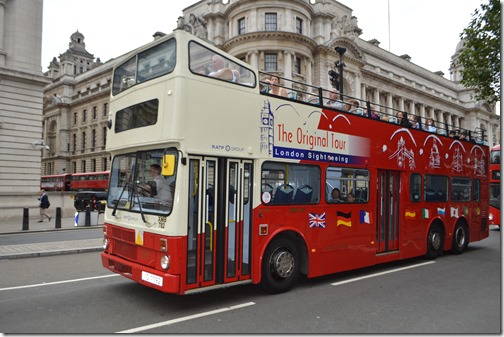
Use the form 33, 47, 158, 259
42, 0, 500, 181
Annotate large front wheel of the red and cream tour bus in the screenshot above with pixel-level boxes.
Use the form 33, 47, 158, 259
261, 238, 301, 293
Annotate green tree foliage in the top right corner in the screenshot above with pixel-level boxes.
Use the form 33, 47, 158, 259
455, 0, 501, 103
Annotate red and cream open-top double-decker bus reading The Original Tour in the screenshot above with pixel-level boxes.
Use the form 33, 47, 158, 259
101, 30, 490, 294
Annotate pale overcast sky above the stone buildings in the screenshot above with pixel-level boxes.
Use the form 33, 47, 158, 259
42, 0, 482, 78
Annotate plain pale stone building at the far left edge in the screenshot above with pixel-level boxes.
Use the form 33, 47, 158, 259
0, 0, 49, 219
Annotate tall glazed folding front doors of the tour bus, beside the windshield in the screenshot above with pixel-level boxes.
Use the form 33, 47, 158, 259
186, 157, 252, 288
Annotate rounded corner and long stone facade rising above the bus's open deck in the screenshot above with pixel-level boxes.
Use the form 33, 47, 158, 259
178, 0, 500, 145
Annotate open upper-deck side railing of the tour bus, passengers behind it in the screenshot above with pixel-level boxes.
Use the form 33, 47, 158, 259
259, 72, 487, 145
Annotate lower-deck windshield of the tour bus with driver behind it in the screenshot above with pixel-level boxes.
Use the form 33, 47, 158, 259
108, 149, 177, 215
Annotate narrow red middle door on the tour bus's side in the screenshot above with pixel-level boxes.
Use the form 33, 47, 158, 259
376, 170, 400, 253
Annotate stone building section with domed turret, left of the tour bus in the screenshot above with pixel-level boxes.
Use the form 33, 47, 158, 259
42, 31, 116, 175
